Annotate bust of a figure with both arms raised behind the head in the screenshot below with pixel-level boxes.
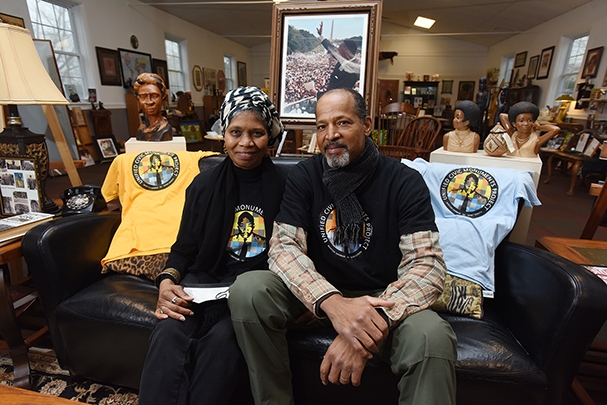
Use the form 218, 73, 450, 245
500, 101, 560, 157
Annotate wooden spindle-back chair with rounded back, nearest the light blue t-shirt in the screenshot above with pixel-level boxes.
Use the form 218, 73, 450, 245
377, 116, 441, 160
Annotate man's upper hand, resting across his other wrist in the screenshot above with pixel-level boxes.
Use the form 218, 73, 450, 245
320, 294, 394, 359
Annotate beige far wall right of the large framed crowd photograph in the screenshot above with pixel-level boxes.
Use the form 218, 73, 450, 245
378, 23, 490, 105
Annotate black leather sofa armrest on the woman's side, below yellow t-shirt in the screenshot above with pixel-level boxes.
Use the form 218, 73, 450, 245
21, 212, 120, 333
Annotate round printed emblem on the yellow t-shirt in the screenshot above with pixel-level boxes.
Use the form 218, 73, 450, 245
132, 151, 180, 190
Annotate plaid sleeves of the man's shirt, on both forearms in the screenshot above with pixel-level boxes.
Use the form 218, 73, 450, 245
268, 222, 447, 328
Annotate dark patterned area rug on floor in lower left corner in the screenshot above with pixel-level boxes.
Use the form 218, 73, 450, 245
0, 347, 139, 405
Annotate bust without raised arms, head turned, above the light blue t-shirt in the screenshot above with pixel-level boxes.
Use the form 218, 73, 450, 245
443, 100, 481, 153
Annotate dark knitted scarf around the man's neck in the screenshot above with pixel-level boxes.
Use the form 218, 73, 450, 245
322, 137, 379, 245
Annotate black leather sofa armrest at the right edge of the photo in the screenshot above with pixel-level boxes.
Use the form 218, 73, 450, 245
492, 242, 607, 404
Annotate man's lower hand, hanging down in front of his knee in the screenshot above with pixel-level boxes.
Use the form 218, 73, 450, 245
320, 335, 367, 387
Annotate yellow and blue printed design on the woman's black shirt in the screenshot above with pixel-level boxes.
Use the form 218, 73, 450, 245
226, 204, 268, 262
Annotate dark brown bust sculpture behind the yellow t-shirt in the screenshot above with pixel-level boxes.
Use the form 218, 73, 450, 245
133, 73, 173, 141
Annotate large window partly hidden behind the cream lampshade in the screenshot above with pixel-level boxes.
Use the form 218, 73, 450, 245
27, 0, 88, 102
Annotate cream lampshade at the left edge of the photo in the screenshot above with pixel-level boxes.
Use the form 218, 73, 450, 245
0, 24, 69, 105
